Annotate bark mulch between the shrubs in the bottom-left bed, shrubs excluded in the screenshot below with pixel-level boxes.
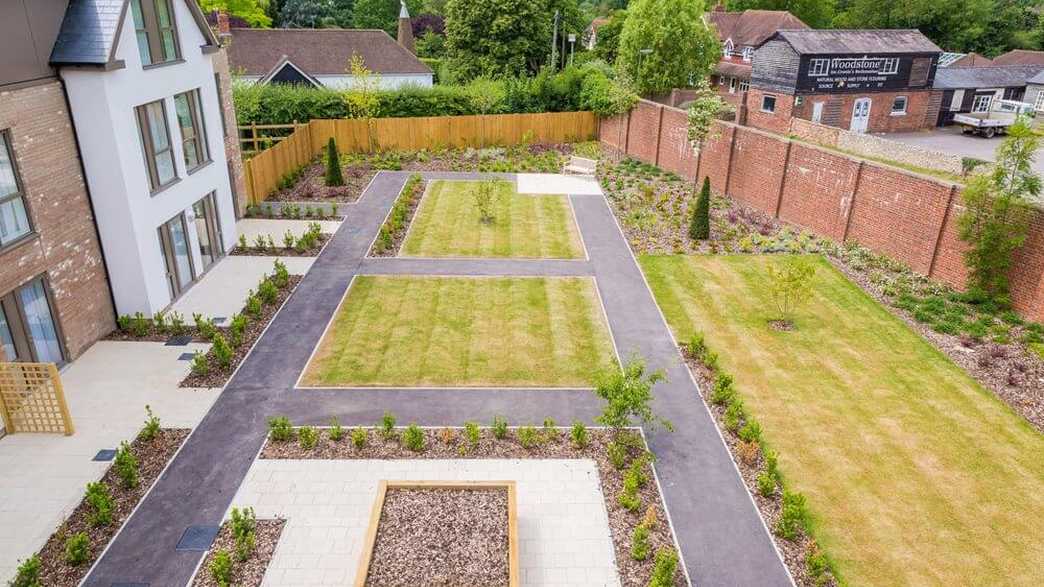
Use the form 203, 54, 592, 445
39, 428, 190, 587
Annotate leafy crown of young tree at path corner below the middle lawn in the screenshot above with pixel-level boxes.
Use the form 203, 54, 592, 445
594, 357, 671, 436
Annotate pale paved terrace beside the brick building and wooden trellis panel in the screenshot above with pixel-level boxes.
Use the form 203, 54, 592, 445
0, 341, 218, 585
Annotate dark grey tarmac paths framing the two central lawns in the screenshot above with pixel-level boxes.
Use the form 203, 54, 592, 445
86, 171, 792, 587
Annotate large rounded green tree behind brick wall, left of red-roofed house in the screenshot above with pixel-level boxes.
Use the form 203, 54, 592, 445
616, 0, 721, 95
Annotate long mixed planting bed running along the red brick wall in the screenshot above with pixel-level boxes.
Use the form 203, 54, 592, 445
597, 154, 1044, 431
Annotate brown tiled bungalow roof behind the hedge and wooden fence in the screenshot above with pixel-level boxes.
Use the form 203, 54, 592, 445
229, 28, 431, 76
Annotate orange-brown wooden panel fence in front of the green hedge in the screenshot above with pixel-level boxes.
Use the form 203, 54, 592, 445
239, 112, 598, 204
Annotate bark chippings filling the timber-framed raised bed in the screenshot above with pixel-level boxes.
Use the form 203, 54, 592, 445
366, 488, 509, 587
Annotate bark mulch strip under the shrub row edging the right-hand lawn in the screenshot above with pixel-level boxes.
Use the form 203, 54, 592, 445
679, 349, 837, 587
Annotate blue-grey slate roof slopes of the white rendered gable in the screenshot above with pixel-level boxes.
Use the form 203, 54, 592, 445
51, 0, 217, 66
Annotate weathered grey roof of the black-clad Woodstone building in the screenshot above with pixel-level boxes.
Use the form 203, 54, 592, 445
770, 28, 943, 55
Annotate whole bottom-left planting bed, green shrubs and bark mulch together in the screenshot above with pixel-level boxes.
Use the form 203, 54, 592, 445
13, 417, 189, 587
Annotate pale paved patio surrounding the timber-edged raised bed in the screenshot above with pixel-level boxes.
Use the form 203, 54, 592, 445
218, 460, 619, 587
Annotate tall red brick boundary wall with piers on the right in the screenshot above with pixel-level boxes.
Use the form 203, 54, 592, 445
599, 100, 1044, 321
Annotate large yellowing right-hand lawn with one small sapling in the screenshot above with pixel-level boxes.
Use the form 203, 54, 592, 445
640, 256, 1044, 585
